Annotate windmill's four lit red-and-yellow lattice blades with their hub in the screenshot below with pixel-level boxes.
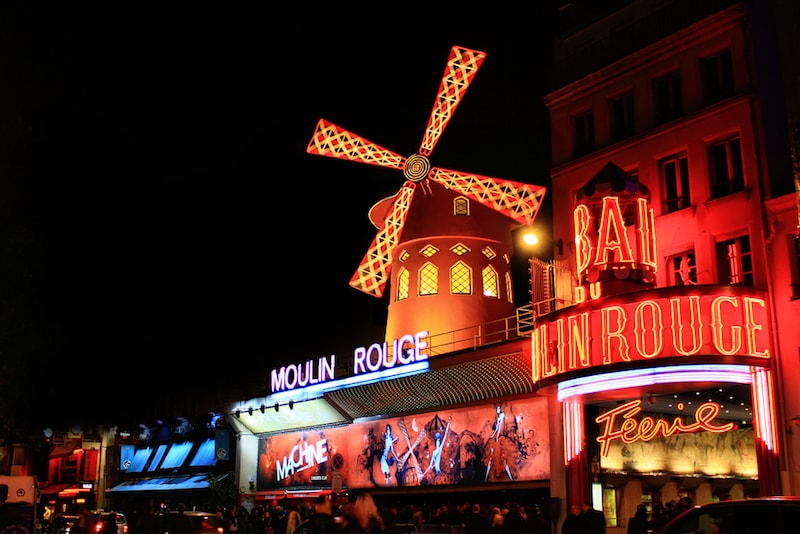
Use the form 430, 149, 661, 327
306, 46, 545, 348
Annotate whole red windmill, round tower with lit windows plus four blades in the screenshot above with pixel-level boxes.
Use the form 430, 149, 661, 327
306, 46, 545, 354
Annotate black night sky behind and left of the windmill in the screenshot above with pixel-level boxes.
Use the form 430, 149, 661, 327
0, 2, 551, 430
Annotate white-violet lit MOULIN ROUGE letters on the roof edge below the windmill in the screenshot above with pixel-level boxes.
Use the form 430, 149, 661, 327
270, 330, 428, 393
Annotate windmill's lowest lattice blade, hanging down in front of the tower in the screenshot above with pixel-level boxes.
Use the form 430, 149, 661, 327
350, 181, 416, 298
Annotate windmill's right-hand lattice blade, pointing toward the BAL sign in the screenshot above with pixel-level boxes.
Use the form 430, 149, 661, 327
430, 167, 546, 225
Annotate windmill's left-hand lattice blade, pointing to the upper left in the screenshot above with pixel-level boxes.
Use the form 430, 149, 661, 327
306, 119, 406, 169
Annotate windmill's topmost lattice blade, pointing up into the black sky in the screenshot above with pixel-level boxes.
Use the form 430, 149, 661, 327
419, 46, 486, 156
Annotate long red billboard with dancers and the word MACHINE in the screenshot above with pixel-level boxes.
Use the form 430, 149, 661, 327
257, 398, 550, 490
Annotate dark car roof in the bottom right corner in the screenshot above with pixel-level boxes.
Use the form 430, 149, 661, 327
658, 496, 800, 534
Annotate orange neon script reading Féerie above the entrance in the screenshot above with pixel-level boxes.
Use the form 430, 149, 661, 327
595, 400, 734, 456
